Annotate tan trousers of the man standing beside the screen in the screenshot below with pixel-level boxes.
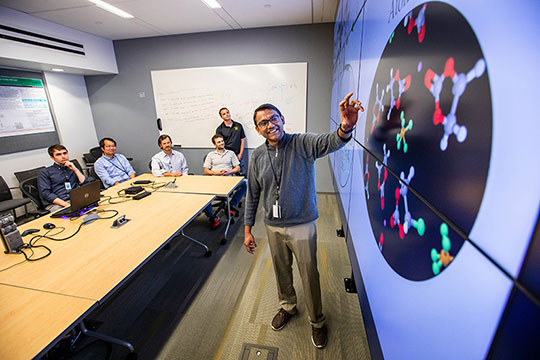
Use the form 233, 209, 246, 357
266, 221, 326, 327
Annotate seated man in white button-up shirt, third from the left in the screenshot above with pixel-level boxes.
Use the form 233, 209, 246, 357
152, 134, 189, 176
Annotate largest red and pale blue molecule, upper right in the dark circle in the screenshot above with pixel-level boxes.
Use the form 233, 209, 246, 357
424, 57, 486, 151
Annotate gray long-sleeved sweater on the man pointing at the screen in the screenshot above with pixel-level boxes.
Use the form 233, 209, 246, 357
245, 132, 352, 226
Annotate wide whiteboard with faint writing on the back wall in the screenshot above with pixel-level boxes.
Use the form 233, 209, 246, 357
151, 62, 307, 148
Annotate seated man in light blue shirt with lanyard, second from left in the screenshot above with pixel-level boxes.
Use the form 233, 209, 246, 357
94, 138, 135, 188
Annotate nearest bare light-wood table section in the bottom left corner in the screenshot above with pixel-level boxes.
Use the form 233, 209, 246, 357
0, 285, 96, 359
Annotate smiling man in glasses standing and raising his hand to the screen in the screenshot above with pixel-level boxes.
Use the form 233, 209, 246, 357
244, 93, 364, 349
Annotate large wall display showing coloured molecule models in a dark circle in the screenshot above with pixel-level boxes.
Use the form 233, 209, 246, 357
330, 0, 540, 359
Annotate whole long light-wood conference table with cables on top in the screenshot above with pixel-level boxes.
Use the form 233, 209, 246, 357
0, 174, 241, 359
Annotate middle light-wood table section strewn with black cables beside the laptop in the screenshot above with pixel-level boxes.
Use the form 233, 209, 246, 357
0, 189, 214, 300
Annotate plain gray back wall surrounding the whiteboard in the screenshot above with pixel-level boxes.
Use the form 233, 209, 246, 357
86, 24, 337, 192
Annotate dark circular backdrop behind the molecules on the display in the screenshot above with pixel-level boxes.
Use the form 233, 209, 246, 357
362, 2, 492, 281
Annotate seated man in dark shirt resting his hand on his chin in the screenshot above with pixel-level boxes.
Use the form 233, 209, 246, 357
37, 144, 86, 212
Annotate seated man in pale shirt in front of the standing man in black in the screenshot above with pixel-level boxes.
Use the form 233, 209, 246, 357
203, 134, 247, 216
